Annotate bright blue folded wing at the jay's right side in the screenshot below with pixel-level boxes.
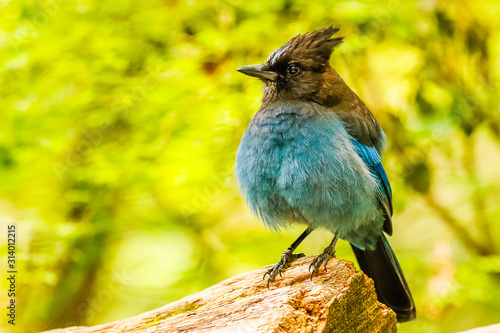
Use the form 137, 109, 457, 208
352, 140, 392, 234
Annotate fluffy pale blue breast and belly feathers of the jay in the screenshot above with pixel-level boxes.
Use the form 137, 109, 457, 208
235, 101, 390, 249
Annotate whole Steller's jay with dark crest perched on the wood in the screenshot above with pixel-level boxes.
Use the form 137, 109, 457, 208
235, 26, 416, 322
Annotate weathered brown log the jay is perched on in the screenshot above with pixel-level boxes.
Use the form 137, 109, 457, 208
41, 257, 397, 333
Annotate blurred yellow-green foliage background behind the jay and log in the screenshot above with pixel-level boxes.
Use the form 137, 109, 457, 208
0, 0, 500, 332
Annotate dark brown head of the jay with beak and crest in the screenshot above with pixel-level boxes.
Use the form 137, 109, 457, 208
238, 26, 344, 101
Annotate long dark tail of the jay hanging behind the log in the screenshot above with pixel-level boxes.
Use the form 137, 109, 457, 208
351, 235, 417, 322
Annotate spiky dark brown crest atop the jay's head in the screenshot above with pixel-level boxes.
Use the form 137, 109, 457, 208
266, 26, 344, 67
